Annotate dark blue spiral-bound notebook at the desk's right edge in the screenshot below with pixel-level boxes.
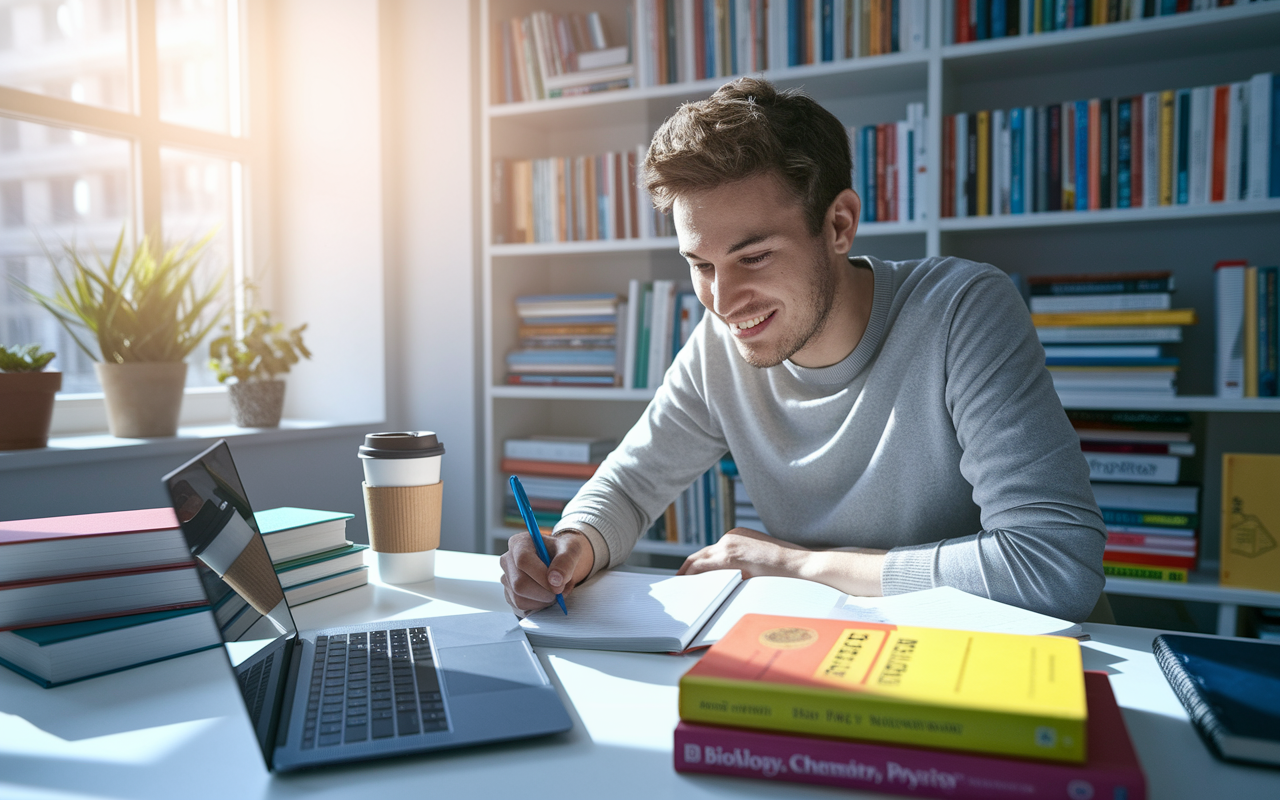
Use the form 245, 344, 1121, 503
1152, 634, 1280, 767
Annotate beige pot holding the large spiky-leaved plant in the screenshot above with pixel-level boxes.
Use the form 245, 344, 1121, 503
93, 361, 187, 439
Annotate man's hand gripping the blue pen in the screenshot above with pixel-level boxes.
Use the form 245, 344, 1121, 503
498, 531, 595, 617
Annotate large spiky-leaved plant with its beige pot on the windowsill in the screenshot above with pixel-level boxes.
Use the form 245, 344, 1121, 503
19, 228, 223, 438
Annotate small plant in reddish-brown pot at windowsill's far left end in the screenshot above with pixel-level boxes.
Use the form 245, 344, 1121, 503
0, 344, 63, 451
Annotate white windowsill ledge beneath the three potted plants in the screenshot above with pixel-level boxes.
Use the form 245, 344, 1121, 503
0, 420, 381, 472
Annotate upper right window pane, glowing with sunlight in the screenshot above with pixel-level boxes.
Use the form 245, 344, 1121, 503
156, 0, 241, 136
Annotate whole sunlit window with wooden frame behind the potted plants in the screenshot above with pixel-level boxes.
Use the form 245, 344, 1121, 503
0, 0, 252, 394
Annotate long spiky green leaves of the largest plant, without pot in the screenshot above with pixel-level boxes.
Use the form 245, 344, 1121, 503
18, 228, 225, 364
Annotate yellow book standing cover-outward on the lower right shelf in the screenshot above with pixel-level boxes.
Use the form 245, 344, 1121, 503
1222, 453, 1280, 591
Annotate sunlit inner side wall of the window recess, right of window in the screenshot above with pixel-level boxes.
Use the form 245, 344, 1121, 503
265, 0, 385, 422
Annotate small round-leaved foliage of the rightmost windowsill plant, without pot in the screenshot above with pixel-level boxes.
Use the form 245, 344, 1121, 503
209, 284, 311, 383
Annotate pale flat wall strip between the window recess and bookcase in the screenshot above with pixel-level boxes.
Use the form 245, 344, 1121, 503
381, 0, 483, 550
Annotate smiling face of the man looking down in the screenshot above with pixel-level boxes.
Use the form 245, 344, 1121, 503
672, 175, 836, 367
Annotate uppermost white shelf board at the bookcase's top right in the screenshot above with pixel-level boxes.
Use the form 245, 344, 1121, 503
942, 3, 1280, 82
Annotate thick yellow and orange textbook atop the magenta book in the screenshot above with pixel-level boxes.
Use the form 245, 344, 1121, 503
680, 614, 1087, 762
